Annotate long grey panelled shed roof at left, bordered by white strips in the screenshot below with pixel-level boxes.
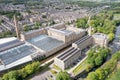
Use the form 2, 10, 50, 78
0, 44, 36, 65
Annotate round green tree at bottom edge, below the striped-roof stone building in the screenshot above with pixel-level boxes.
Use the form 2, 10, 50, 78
56, 71, 72, 80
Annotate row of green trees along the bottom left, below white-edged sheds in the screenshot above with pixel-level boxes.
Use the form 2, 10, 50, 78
2, 61, 40, 80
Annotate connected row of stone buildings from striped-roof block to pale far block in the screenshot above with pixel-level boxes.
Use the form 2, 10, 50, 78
54, 33, 108, 70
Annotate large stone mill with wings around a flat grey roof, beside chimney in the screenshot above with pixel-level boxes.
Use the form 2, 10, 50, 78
21, 23, 86, 57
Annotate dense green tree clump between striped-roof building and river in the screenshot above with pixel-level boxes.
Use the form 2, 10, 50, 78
86, 46, 109, 72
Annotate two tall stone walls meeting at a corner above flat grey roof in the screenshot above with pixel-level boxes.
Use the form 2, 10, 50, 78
48, 28, 86, 43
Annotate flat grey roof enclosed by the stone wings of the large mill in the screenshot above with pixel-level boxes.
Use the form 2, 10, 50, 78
28, 35, 64, 52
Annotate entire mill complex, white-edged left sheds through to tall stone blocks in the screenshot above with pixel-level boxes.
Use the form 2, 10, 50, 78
0, 23, 86, 71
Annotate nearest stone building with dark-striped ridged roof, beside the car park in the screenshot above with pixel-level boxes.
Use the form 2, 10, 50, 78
54, 47, 81, 70
